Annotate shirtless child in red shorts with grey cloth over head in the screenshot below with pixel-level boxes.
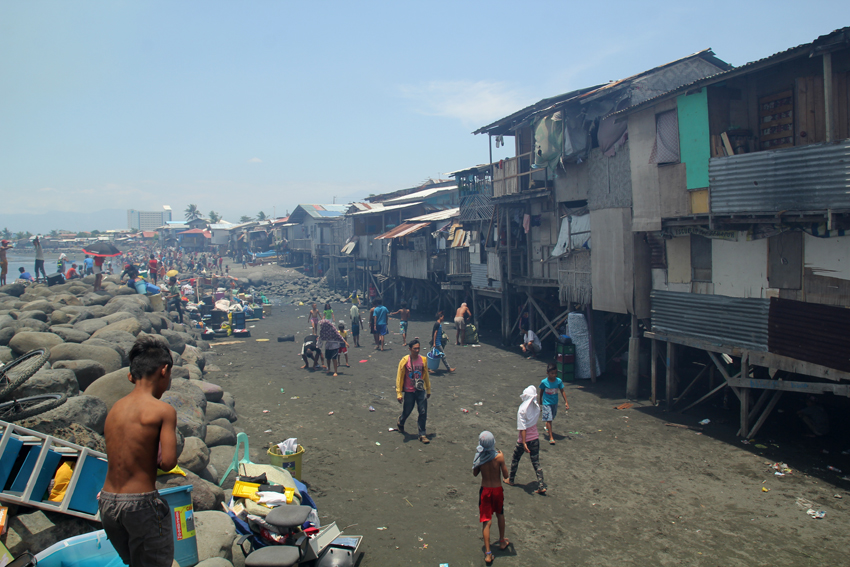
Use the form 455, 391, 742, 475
472, 431, 511, 565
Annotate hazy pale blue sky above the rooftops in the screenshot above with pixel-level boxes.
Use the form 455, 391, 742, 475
0, 0, 850, 231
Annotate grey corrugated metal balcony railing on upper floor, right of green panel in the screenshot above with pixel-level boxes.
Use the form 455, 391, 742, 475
709, 140, 850, 214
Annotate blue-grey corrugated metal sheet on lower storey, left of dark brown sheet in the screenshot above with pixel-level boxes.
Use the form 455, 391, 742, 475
650, 291, 770, 351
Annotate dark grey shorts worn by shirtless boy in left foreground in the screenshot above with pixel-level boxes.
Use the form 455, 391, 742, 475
98, 491, 174, 567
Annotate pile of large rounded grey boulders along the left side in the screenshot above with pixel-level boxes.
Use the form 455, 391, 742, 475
0, 276, 245, 559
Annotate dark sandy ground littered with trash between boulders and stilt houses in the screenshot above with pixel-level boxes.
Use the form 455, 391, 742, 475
207, 268, 850, 567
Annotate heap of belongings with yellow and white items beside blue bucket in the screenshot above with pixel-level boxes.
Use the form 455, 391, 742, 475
222, 463, 321, 549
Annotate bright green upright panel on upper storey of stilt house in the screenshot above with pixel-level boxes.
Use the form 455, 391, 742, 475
676, 89, 711, 190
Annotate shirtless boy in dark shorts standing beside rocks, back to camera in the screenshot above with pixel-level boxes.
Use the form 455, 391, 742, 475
98, 336, 177, 567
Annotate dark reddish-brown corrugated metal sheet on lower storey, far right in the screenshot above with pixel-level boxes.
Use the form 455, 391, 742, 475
768, 298, 850, 372
